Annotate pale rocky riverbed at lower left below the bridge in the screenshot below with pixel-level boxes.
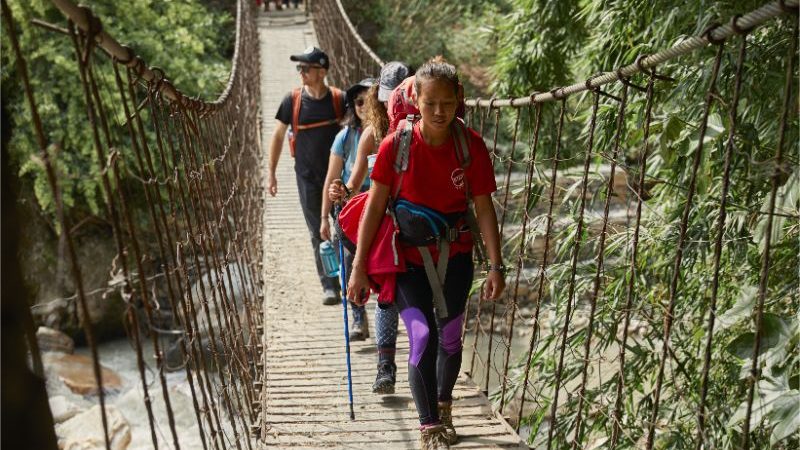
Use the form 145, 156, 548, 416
38, 329, 228, 450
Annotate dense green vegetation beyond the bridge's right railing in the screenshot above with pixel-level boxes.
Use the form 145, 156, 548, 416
345, 0, 800, 448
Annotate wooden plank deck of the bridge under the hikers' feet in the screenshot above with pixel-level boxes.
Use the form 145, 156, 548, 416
259, 7, 527, 449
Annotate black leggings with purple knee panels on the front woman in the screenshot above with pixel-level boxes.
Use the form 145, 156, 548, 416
396, 253, 473, 425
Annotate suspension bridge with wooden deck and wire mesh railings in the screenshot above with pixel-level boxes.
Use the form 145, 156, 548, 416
2, 0, 798, 450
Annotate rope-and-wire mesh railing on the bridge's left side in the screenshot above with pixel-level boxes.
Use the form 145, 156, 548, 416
2, 0, 264, 450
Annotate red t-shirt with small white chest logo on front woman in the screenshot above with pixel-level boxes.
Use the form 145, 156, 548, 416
371, 123, 497, 265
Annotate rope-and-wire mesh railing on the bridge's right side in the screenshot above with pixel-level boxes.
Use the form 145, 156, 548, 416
315, 0, 799, 449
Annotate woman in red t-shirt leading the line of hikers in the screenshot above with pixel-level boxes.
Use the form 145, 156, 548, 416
347, 58, 505, 449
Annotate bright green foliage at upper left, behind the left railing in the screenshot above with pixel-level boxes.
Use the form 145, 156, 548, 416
2, 0, 234, 225
